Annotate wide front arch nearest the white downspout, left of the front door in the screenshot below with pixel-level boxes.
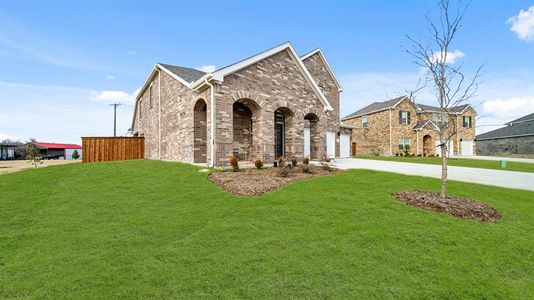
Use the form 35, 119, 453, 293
232, 99, 260, 161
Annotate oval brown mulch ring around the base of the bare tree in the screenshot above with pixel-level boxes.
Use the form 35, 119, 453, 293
393, 191, 501, 222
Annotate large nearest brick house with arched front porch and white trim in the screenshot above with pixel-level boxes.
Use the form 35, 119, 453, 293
131, 42, 351, 166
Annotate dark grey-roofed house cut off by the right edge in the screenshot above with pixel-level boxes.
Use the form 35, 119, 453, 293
476, 113, 534, 155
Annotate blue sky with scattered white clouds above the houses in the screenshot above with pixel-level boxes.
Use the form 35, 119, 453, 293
0, 0, 534, 143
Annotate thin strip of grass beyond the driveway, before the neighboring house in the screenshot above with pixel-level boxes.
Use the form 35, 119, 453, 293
354, 155, 534, 173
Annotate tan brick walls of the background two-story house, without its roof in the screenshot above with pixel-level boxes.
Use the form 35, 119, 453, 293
343, 98, 476, 155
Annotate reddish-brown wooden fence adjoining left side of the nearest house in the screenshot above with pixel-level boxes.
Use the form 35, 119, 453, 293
82, 137, 145, 162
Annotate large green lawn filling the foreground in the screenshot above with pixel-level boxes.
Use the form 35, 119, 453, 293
0, 161, 534, 299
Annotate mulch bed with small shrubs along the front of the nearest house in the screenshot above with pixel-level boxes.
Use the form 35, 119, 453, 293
209, 166, 340, 196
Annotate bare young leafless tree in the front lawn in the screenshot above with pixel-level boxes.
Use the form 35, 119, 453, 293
406, 0, 482, 198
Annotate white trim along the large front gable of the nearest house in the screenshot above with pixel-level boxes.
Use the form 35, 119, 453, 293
190, 42, 334, 110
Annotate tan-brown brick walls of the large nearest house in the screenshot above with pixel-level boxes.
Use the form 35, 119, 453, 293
132, 50, 340, 166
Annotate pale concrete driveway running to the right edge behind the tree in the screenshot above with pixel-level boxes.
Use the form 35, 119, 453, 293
333, 158, 534, 191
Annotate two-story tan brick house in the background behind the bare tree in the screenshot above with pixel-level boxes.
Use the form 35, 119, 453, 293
341, 96, 476, 155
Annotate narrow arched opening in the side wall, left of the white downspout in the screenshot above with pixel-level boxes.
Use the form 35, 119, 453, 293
193, 99, 208, 163
